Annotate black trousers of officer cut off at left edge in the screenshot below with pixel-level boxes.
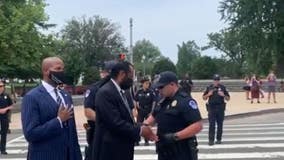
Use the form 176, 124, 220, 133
0, 115, 9, 152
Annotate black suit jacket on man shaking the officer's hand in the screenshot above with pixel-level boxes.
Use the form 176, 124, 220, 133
92, 81, 140, 160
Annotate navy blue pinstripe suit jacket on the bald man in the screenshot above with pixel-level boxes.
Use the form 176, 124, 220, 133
21, 85, 82, 160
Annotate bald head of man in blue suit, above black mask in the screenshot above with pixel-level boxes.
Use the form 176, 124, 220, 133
41, 57, 64, 82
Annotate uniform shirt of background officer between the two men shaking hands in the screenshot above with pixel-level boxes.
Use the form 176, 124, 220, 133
134, 89, 155, 108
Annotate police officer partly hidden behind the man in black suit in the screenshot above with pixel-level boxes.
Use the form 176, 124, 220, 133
84, 61, 117, 159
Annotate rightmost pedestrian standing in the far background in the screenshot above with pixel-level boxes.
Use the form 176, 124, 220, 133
267, 70, 277, 103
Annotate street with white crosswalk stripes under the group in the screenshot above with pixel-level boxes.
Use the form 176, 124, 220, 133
0, 112, 284, 160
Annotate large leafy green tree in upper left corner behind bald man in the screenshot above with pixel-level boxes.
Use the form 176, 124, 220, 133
0, 0, 53, 79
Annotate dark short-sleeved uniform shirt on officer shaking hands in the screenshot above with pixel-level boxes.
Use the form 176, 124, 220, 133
153, 91, 202, 135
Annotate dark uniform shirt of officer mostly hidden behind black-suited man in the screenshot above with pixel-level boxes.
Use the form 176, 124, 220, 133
84, 80, 107, 111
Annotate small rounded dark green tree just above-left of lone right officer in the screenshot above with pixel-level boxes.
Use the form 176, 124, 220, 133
192, 56, 218, 79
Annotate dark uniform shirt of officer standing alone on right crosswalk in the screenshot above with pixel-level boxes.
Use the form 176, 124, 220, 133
203, 84, 230, 105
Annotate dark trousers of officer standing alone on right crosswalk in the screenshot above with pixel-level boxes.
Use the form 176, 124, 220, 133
208, 106, 225, 142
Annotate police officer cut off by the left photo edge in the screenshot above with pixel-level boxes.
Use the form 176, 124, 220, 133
0, 80, 13, 154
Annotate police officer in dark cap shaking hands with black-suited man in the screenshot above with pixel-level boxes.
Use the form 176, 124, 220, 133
144, 71, 202, 160
